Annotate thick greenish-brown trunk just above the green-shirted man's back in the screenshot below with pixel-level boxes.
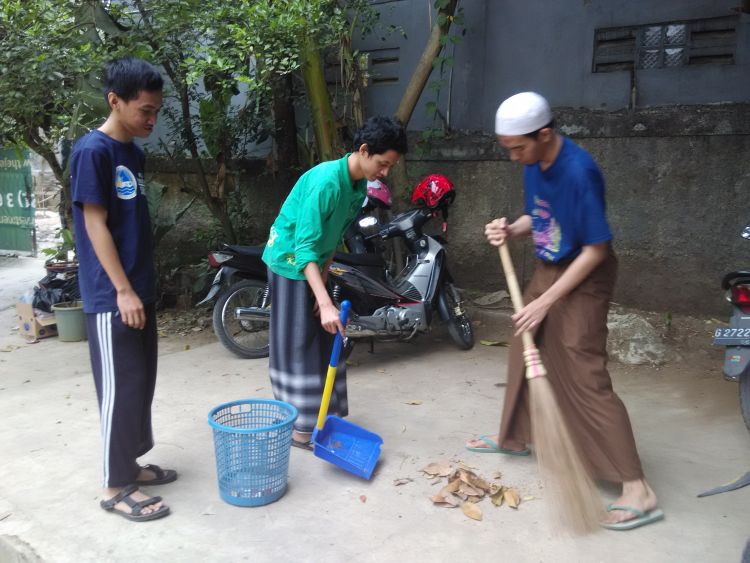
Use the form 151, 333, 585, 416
302, 36, 341, 161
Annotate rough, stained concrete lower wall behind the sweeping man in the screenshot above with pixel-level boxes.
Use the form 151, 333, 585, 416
409, 104, 750, 315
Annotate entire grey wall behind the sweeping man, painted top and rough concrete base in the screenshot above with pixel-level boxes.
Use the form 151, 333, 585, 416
352, 0, 750, 315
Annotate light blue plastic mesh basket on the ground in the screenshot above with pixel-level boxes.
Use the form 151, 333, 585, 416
208, 399, 298, 506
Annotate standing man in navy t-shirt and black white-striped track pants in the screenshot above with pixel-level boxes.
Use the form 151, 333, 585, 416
70, 58, 177, 521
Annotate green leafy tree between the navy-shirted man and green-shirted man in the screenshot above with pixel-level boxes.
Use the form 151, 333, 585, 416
111, 0, 378, 241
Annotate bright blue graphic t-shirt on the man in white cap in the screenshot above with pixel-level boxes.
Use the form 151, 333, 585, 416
524, 137, 612, 262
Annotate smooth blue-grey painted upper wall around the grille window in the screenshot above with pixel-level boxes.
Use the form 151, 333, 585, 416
357, 0, 750, 131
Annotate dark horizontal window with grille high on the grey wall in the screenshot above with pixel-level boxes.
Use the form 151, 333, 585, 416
593, 16, 738, 72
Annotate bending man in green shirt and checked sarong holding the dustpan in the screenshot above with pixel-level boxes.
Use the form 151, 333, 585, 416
263, 117, 408, 449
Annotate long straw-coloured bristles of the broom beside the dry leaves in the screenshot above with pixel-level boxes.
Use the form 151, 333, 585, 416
528, 377, 602, 534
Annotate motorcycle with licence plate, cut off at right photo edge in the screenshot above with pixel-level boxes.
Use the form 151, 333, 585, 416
713, 220, 750, 431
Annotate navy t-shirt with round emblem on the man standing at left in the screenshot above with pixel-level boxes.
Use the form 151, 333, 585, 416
70, 130, 156, 313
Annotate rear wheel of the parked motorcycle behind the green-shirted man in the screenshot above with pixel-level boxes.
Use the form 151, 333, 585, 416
213, 280, 271, 358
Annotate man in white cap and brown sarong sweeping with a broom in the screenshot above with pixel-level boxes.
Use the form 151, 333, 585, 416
466, 92, 664, 530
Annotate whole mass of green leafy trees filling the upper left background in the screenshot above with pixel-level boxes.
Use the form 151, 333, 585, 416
0, 0, 384, 241
